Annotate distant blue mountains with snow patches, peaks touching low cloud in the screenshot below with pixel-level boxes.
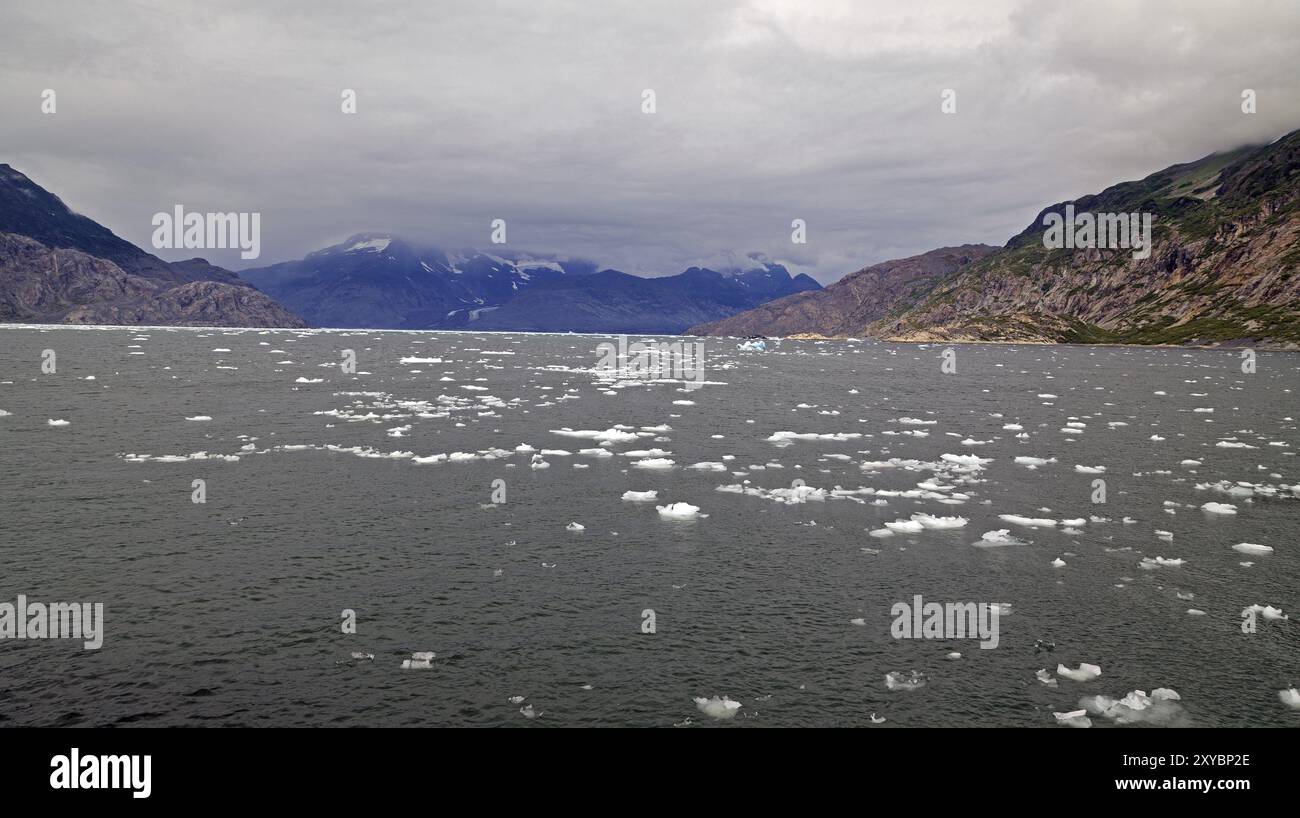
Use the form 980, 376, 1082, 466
243, 233, 820, 333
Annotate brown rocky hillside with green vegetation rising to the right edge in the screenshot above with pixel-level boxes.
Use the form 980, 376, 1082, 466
689, 131, 1300, 347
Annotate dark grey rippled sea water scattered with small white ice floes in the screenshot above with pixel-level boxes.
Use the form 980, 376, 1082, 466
0, 322, 1300, 730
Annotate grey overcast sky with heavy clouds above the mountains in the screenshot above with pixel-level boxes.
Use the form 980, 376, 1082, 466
0, 0, 1300, 282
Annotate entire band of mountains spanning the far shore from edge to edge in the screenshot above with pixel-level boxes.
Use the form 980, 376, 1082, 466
0, 131, 1300, 347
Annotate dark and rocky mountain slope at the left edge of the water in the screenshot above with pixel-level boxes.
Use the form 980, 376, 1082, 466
0, 164, 306, 326
